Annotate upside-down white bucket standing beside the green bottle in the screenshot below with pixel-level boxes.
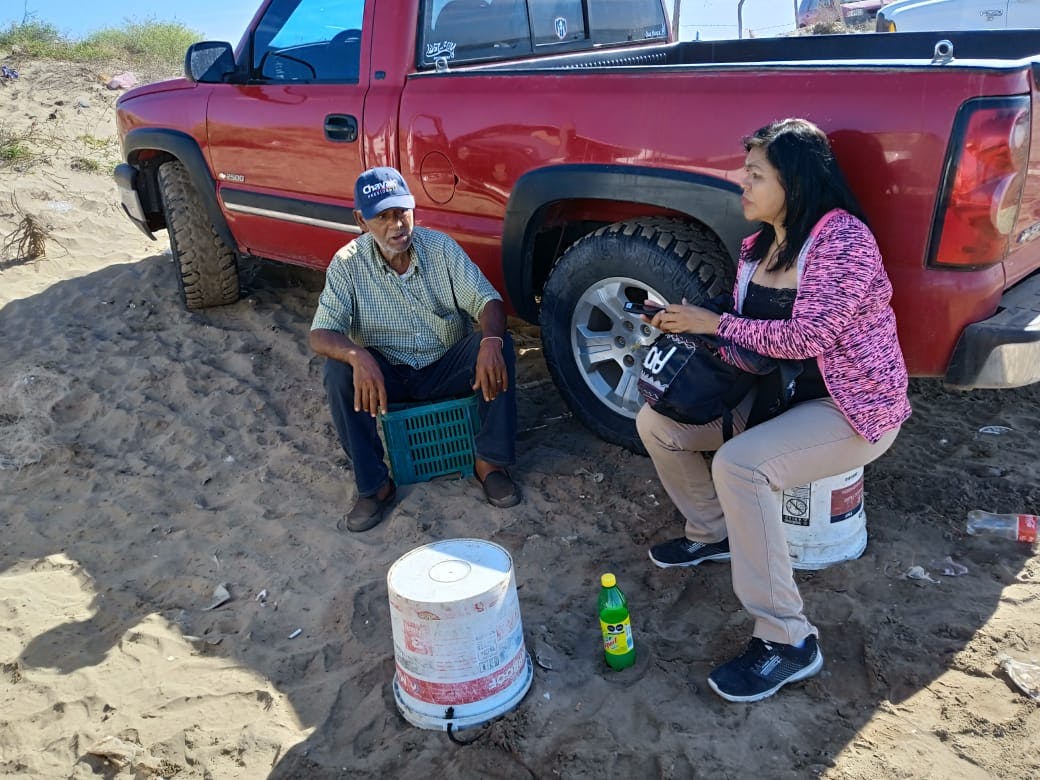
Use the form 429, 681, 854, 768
387, 539, 534, 731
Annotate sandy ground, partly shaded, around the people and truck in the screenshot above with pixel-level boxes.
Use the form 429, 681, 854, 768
0, 59, 1040, 780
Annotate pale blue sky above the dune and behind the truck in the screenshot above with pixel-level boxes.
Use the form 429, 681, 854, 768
0, 0, 795, 44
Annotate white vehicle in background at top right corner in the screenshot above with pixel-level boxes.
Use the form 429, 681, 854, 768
877, 0, 1040, 32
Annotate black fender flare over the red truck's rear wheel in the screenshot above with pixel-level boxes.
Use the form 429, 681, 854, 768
502, 163, 753, 322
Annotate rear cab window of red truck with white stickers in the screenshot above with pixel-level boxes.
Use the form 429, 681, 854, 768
419, 0, 668, 68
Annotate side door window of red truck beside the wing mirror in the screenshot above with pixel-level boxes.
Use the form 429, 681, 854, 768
251, 0, 365, 83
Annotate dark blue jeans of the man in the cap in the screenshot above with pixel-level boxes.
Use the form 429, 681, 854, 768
324, 332, 517, 496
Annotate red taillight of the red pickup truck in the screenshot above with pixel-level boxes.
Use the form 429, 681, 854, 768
929, 96, 1030, 268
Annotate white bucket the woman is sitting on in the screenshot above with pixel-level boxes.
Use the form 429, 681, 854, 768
780, 468, 866, 569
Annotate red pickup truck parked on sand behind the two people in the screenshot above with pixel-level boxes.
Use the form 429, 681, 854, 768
115, 0, 1040, 448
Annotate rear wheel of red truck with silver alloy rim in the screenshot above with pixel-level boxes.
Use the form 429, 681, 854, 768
541, 217, 733, 452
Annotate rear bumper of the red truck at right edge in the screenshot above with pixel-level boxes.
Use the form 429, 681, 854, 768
943, 275, 1040, 390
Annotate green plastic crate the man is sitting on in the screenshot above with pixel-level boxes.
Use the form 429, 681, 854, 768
380, 395, 479, 485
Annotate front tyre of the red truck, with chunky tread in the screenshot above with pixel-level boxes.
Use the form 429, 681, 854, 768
159, 161, 238, 309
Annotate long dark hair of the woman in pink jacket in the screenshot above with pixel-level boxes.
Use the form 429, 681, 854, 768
744, 119, 866, 270
